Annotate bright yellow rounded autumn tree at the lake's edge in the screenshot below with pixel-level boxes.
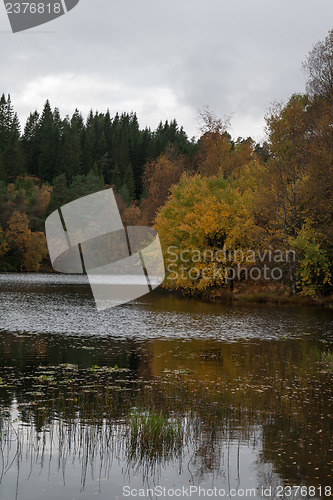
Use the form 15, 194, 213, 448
156, 174, 258, 292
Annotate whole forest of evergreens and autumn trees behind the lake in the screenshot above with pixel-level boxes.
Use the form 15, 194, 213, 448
0, 31, 333, 297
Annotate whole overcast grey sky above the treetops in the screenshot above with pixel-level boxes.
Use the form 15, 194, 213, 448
0, 0, 333, 140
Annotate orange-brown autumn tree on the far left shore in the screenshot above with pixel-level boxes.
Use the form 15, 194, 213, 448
6, 211, 47, 271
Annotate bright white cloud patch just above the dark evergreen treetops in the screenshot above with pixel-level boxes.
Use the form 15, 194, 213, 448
12, 73, 187, 133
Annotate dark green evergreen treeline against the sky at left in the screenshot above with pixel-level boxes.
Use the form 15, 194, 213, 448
0, 95, 195, 200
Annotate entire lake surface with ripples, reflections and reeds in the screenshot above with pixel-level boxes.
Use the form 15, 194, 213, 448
0, 274, 333, 500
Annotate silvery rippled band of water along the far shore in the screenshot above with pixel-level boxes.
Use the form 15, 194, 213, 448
0, 274, 333, 341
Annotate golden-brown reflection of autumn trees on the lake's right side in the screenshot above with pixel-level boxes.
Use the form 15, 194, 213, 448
150, 339, 333, 485
